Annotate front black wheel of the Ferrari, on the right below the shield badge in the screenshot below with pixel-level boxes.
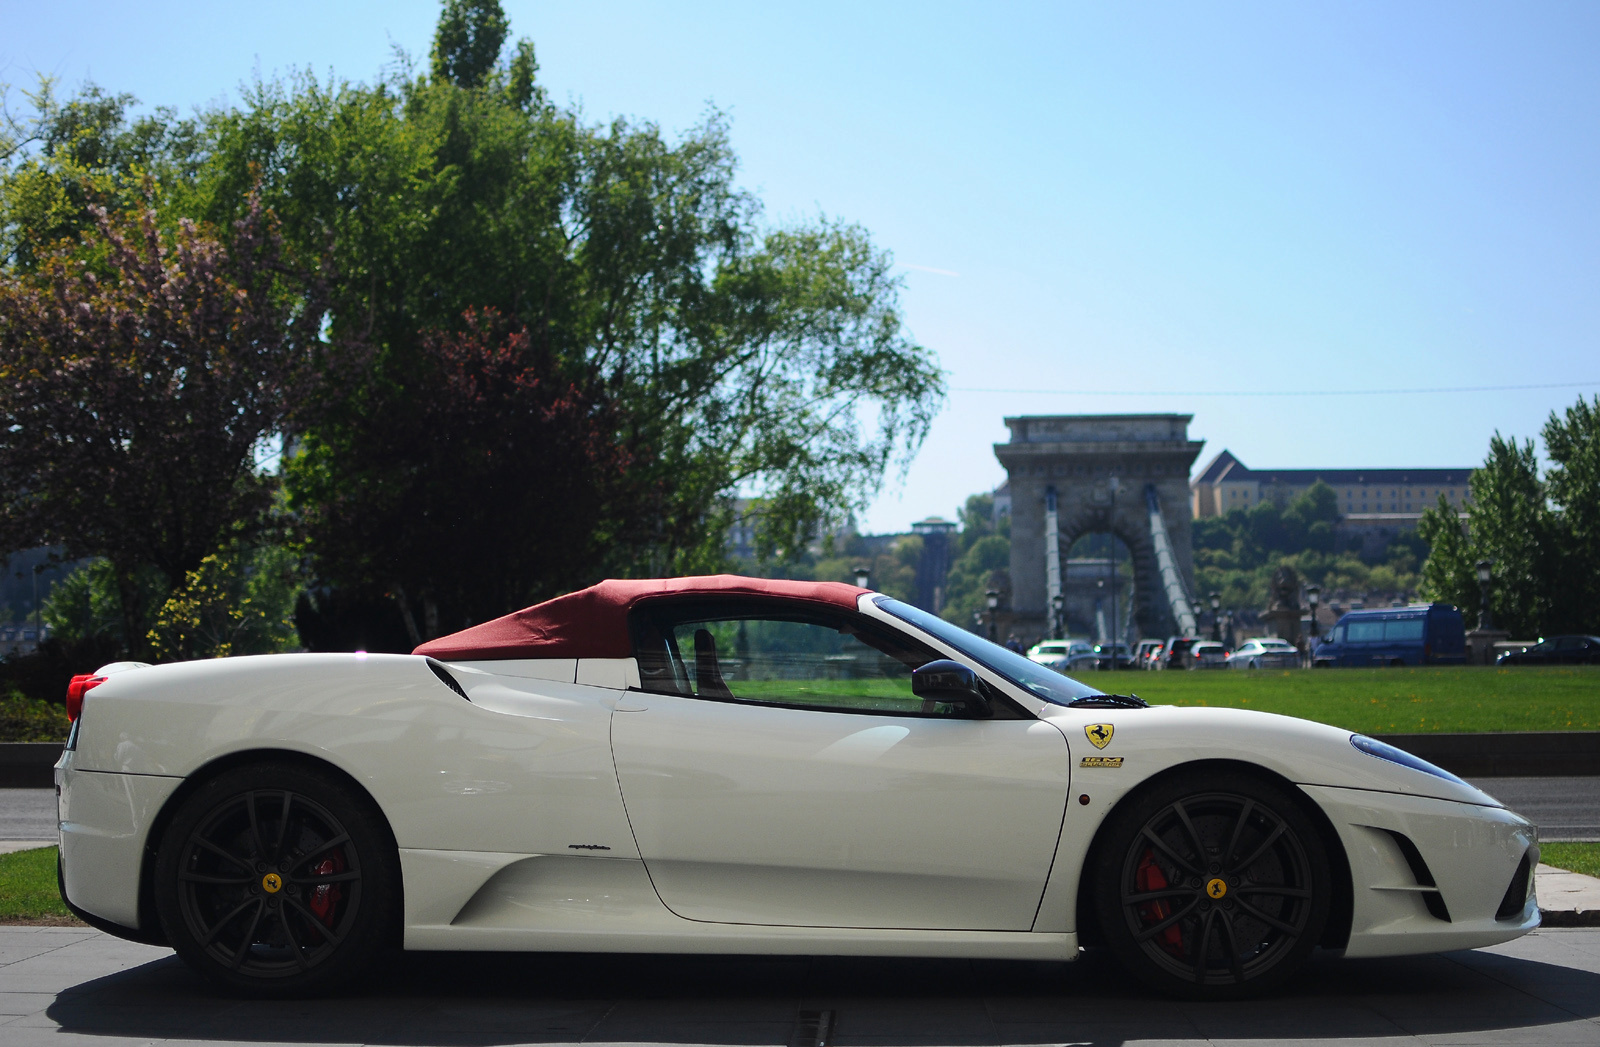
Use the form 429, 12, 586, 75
1090, 772, 1333, 999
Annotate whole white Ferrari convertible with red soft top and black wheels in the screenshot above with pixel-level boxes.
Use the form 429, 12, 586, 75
56, 576, 1539, 997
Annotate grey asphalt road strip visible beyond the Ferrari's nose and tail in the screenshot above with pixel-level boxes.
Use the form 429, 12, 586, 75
9, 778, 1600, 840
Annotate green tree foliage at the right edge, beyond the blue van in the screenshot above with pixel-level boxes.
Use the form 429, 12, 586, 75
1421, 399, 1600, 637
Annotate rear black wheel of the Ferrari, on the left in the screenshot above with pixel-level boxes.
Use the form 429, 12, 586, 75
155, 764, 400, 996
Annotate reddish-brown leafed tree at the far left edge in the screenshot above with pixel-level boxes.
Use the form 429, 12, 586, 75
0, 202, 322, 648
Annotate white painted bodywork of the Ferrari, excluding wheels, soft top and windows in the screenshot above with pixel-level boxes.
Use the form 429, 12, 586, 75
58, 599, 1538, 959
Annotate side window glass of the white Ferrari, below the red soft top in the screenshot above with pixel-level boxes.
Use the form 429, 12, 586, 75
634, 600, 979, 717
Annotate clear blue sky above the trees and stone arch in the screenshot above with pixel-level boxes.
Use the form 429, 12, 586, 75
0, 0, 1600, 532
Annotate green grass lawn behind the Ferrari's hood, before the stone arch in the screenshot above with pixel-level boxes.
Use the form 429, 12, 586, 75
1113, 666, 1600, 735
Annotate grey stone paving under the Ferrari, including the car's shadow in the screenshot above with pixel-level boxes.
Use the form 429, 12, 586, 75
0, 927, 1600, 1047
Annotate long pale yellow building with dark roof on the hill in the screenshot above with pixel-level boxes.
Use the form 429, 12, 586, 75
1189, 451, 1472, 552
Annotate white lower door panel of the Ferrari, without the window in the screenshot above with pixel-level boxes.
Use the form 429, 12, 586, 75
611, 695, 1070, 930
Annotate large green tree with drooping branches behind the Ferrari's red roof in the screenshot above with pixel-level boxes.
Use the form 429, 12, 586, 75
184, 6, 944, 637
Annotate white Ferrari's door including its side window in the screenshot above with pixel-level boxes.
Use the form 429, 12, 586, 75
611, 604, 1069, 930
